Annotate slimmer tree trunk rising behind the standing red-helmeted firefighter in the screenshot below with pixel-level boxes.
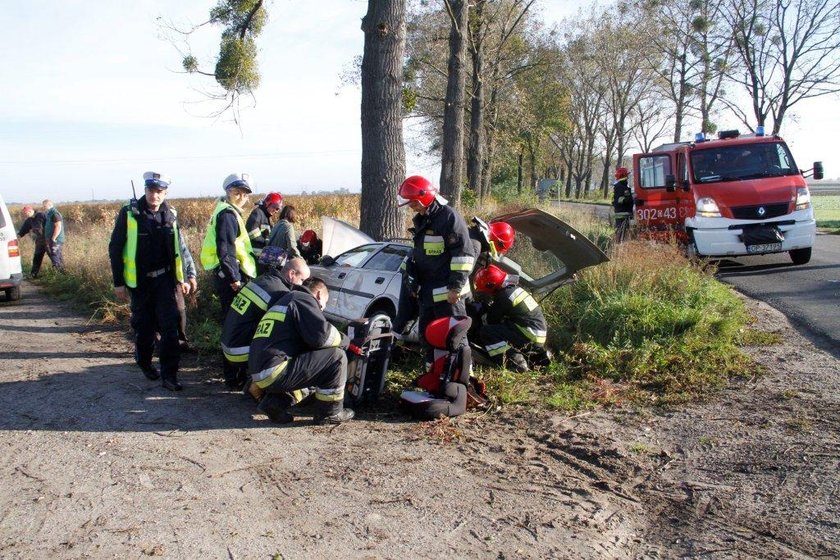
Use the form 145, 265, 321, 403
436, 0, 469, 206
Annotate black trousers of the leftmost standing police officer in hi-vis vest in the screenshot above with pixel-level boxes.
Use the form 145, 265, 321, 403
129, 274, 181, 380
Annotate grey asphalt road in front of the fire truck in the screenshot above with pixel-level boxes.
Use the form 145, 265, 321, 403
718, 235, 840, 356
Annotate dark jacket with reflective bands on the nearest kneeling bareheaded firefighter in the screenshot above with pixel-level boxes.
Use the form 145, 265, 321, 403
248, 286, 349, 389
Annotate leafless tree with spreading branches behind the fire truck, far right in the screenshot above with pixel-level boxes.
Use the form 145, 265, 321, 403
727, 0, 840, 134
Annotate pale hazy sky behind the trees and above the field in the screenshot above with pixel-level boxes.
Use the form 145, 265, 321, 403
0, 0, 840, 206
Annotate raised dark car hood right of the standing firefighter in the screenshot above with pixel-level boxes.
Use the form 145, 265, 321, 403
492, 208, 609, 298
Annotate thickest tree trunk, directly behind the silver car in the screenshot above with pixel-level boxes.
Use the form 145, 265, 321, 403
359, 0, 405, 240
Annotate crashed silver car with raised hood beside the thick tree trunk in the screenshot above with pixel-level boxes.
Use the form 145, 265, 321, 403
311, 208, 609, 341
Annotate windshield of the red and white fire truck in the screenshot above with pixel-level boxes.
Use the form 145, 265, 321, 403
691, 142, 799, 183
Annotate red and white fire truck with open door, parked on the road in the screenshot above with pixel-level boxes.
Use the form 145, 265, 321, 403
633, 127, 823, 264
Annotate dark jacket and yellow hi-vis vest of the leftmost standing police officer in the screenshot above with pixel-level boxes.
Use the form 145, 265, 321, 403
108, 196, 184, 288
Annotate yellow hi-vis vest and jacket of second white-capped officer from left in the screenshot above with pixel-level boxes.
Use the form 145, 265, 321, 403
201, 198, 257, 283
